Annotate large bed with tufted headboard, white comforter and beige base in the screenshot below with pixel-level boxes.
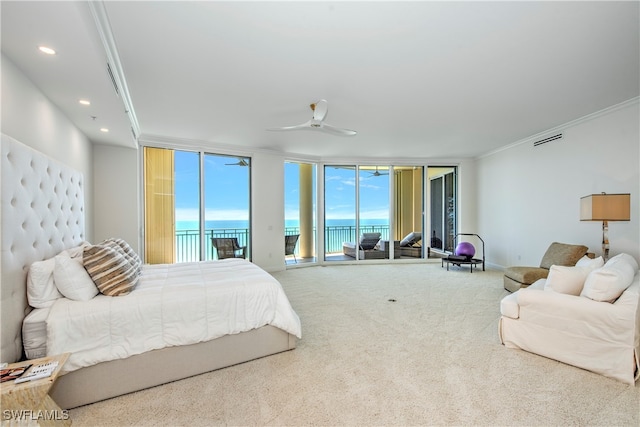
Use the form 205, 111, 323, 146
1, 134, 301, 409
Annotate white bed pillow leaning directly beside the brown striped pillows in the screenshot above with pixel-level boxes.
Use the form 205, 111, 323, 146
53, 252, 98, 301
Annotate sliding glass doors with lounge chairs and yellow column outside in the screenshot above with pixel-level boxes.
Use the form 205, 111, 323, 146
324, 165, 429, 261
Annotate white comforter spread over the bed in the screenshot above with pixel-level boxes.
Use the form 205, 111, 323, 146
47, 259, 301, 371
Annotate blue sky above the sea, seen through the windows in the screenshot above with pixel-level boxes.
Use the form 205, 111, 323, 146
175, 151, 389, 226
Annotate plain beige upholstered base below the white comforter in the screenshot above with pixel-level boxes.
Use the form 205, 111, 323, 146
49, 325, 297, 409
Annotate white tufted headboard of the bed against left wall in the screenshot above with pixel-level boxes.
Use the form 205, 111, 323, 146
0, 134, 85, 362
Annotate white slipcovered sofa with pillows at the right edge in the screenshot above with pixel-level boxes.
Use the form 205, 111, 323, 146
499, 254, 640, 385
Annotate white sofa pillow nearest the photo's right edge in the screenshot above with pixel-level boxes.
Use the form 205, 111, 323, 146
580, 262, 635, 302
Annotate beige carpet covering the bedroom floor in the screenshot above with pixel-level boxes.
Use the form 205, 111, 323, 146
70, 262, 640, 426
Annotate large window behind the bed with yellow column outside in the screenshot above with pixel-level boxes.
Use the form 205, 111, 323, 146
143, 147, 251, 264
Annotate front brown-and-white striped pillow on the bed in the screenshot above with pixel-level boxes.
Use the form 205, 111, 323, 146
82, 242, 139, 296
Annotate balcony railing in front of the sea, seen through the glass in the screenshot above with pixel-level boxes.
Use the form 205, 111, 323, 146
176, 225, 389, 262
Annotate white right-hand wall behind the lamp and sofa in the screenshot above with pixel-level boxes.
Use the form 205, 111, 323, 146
475, 99, 640, 267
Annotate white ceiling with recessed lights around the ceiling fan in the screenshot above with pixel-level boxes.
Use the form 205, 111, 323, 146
1, 1, 640, 159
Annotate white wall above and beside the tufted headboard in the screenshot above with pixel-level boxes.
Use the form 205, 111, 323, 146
0, 54, 94, 241
